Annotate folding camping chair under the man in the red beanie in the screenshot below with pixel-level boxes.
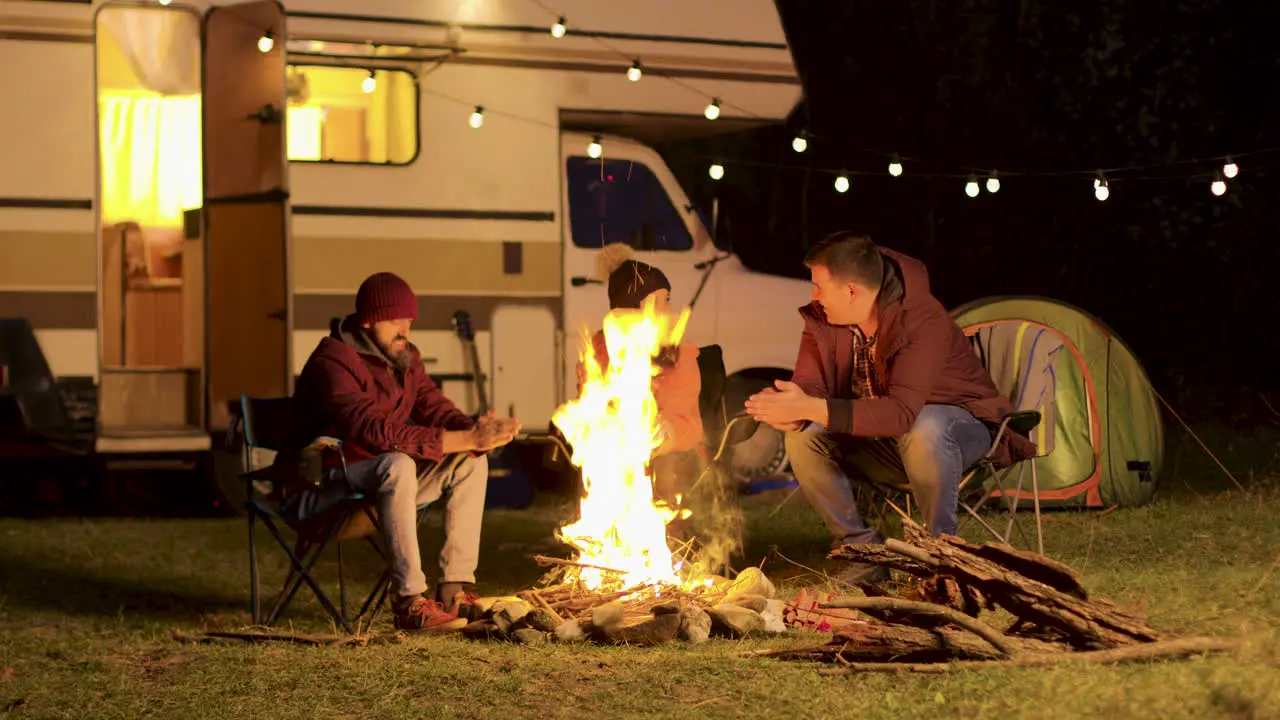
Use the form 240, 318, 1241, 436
228, 395, 404, 633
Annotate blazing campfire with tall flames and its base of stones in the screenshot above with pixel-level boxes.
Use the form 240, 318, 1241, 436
463, 294, 785, 644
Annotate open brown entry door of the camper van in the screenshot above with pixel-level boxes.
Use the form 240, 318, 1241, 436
204, 0, 293, 428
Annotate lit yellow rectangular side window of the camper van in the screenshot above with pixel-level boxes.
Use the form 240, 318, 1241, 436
288, 65, 419, 165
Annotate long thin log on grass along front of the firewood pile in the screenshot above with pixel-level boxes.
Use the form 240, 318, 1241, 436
819, 638, 1239, 675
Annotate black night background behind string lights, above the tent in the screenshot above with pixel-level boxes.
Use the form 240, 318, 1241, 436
662, 0, 1280, 424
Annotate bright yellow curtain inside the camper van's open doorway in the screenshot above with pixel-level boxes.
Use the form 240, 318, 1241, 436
100, 92, 202, 228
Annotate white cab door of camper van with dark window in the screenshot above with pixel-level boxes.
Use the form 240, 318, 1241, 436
561, 133, 716, 398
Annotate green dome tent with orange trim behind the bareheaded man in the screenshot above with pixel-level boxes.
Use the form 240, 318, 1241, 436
952, 297, 1164, 507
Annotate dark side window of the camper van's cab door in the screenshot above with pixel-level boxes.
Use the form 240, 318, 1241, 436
566, 156, 694, 250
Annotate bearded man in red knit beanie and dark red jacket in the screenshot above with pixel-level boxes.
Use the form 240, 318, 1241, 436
276, 273, 520, 629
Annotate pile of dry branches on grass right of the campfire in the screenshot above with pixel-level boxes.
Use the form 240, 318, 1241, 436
749, 519, 1235, 674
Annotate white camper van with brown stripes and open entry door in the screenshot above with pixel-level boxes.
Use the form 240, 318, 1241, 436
0, 0, 809, 471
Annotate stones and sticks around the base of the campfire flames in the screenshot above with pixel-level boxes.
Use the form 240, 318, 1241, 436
462, 556, 786, 646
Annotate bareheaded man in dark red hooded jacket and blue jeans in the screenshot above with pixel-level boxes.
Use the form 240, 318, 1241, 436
748, 232, 1034, 579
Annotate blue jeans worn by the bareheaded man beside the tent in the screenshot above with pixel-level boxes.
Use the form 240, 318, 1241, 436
786, 405, 992, 546
